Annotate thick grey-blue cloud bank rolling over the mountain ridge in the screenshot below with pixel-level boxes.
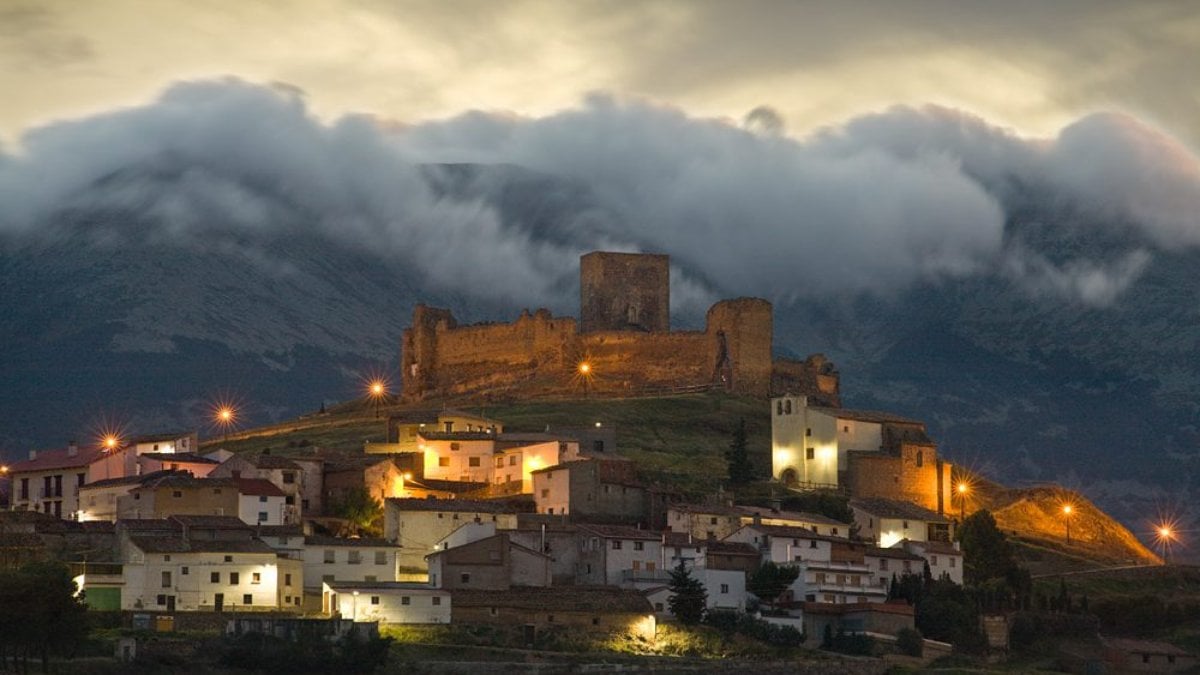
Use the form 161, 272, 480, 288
0, 79, 1200, 309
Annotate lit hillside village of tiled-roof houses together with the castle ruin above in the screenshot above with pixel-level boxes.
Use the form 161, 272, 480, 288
0, 253, 1195, 668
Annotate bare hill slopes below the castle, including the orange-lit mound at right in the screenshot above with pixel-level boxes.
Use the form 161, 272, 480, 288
203, 393, 1160, 566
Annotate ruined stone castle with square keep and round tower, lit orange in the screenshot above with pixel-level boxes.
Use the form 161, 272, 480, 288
401, 251, 838, 405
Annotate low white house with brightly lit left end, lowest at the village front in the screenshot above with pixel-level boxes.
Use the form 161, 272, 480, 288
322, 581, 450, 623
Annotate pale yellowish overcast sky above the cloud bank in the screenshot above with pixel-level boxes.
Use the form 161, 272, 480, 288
0, 0, 1200, 149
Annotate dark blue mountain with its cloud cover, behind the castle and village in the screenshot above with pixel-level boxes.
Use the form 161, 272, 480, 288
0, 79, 1200, 552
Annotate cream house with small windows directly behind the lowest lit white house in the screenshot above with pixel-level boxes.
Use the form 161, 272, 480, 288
304, 534, 400, 590
